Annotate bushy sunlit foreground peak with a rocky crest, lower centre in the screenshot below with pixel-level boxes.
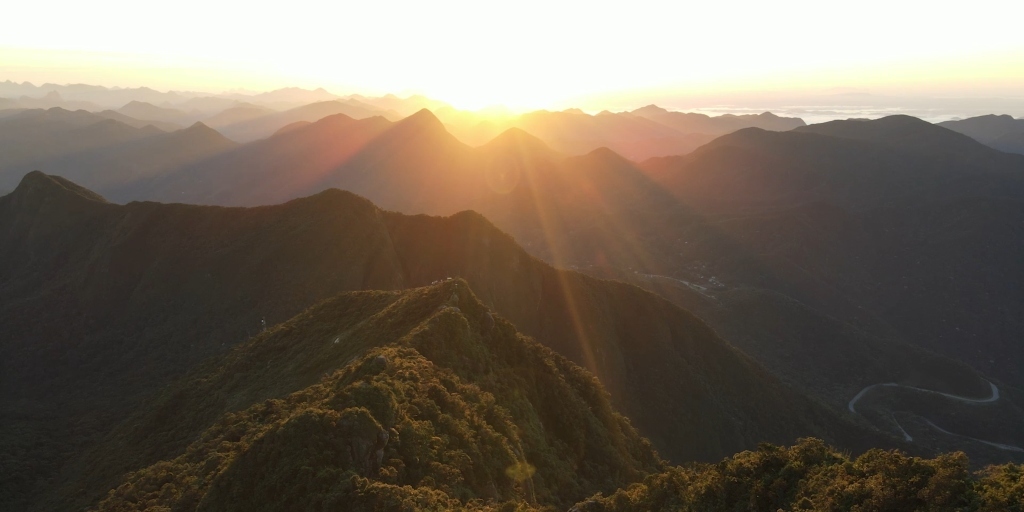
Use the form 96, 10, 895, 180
83, 281, 658, 510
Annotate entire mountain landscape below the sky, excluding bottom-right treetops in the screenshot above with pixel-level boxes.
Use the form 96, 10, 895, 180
6, 86, 1024, 511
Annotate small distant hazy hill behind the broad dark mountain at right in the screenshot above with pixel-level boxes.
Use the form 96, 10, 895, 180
630, 104, 805, 135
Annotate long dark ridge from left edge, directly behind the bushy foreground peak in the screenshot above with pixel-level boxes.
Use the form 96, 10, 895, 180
0, 173, 896, 508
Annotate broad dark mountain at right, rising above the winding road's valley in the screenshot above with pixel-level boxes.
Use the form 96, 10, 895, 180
644, 117, 1024, 397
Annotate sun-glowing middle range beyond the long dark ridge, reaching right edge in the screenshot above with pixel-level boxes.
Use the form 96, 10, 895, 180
119, 111, 1022, 452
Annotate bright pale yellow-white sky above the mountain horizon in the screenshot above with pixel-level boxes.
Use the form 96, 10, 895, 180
0, 0, 1024, 108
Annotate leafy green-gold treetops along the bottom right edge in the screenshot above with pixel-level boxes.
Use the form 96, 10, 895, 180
574, 438, 1024, 512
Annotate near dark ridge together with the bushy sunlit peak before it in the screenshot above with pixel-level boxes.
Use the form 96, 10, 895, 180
8, 168, 1024, 510
